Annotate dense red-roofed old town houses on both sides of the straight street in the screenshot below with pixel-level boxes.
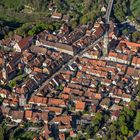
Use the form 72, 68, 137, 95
0, 18, 140, 139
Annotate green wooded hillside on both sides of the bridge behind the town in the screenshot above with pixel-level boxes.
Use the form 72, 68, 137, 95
0, 0, 140, 37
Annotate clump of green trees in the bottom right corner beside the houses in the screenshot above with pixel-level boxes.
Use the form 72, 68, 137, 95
104, 101, 140, 140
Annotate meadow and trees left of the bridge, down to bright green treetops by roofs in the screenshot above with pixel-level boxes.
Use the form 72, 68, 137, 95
0, 0, 106, 39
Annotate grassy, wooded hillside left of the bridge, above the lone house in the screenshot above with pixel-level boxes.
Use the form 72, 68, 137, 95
0, 0, 108, 37
